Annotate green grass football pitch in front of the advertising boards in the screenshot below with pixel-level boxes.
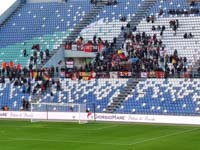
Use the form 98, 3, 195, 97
0, 120, 200, 150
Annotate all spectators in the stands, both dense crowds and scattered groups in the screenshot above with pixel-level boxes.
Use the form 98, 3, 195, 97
0, 0, 200, 111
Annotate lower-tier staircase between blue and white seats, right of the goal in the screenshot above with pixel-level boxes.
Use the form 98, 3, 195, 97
106, 78, 139, 113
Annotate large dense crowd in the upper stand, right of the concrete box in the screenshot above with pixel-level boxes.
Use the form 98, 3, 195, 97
62, 6, 200, 76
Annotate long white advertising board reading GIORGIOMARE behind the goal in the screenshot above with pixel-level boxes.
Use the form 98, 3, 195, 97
0, 111, 200, 125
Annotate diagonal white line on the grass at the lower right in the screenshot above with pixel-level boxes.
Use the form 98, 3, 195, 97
129, 128, 200, 146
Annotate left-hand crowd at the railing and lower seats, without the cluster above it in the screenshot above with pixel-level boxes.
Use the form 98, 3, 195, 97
0, 62, 61, 111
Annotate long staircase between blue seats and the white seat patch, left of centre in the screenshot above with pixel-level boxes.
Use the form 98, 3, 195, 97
39, 3, 105, 67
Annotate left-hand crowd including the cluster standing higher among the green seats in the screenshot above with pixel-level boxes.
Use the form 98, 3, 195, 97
0, 41, 61, 110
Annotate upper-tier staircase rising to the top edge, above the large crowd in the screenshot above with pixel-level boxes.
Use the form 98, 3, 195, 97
113, 0, 156, 48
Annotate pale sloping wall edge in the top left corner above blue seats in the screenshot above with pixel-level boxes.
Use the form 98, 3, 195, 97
0, 0, 21, 24
